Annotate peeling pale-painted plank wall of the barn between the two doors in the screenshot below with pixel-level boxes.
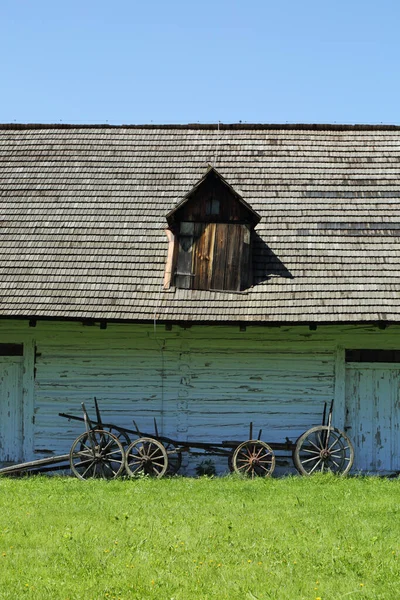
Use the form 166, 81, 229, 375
0, 321, 400, 467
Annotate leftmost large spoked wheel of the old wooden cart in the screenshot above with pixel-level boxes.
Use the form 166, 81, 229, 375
69, 429, 125, 479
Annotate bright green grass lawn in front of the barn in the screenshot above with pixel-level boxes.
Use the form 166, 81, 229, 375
0, 476, 400, 600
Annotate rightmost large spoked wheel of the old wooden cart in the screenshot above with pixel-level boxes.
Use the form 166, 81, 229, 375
293, 425, 354, 475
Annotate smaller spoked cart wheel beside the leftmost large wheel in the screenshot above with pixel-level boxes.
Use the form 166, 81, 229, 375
125, 437, 168, 477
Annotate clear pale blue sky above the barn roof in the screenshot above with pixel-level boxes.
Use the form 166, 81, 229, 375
0, 0, 400, 124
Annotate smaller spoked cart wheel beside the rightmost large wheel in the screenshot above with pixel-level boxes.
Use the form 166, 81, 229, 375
232, 440, 275, 479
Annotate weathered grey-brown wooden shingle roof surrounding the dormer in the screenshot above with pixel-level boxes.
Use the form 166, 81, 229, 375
0, 120, 400, 323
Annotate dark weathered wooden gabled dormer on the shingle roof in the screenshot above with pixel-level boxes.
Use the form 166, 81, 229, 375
167, 168, 260, 291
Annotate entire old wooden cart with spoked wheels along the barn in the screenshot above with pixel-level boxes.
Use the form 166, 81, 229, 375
0, 399, 354, 479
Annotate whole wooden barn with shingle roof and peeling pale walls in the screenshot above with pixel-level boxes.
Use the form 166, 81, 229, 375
0, 124, 400, 473
